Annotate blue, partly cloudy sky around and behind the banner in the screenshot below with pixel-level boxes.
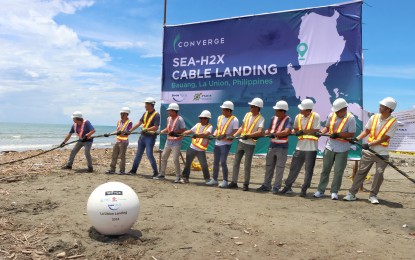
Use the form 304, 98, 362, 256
0, 0, 415, 125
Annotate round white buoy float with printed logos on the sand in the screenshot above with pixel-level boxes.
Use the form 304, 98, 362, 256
87, 182, 140, 235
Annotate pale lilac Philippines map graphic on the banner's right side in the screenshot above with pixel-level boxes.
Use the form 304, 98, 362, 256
287, 11, 363, 151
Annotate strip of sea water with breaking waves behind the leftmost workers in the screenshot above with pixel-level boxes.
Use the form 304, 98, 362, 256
0, 123, 158, 152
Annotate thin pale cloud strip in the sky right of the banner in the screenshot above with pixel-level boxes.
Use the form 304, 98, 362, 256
363, 65, 415, 79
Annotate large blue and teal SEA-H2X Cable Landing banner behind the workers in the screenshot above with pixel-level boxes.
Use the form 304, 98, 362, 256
160, 1, 363, 157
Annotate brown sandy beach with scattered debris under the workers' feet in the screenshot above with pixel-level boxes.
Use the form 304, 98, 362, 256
0, 149, 415, 260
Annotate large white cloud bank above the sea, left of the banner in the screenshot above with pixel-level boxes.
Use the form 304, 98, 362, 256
0, 0, 161, 124
